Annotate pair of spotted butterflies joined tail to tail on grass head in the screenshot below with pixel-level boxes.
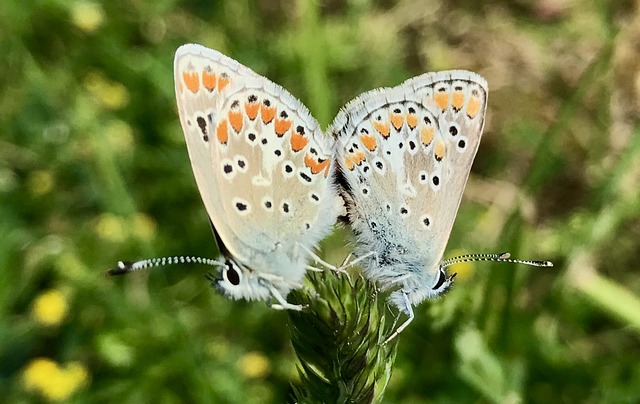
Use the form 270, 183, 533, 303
111, 44, 552, 340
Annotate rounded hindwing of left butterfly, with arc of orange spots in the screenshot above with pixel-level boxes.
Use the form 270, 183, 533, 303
207, 79, 336, 256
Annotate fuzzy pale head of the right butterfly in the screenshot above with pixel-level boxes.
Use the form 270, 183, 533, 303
389, 266, 457, 313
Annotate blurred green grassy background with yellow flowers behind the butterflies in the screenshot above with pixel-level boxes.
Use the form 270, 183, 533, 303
0, 0, 640, 403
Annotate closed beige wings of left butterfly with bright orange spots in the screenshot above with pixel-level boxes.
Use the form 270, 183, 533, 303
175, 45, 337, 293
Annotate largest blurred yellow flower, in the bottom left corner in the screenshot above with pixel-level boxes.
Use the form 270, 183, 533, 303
22, 358, 89, 401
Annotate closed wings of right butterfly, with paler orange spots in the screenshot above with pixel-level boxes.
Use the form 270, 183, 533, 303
330, 71, 487, 294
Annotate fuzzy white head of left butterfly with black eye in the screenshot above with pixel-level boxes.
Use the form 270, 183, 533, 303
207, 259, 271, 300
